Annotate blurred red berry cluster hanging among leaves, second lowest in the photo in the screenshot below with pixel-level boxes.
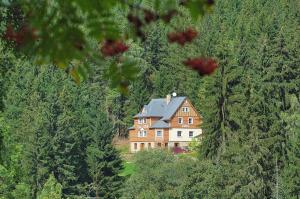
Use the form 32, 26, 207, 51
101, 40, 129, 57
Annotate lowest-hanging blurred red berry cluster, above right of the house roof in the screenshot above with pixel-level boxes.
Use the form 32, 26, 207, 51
183, 58, 218, 75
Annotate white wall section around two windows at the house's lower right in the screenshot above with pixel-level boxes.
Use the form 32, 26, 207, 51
169, 128, 202, 142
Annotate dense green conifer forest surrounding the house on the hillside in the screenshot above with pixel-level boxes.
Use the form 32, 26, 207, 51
0, 0, 300, 199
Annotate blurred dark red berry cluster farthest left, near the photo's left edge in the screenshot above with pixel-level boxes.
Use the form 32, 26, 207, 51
4, 24, 37, 46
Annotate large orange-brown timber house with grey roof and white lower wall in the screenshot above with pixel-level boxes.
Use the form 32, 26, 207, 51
129, 93, 202, 152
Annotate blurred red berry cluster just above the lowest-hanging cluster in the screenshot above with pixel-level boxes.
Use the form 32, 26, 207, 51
168, 28, 198, 46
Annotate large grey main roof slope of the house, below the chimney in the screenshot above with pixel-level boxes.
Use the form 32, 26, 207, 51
135, 97, 186, 120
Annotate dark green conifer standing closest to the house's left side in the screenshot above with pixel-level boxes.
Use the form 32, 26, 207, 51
87, 113, 122, 198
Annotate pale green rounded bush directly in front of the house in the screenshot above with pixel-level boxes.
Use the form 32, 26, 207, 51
123, 150, 196, 198
